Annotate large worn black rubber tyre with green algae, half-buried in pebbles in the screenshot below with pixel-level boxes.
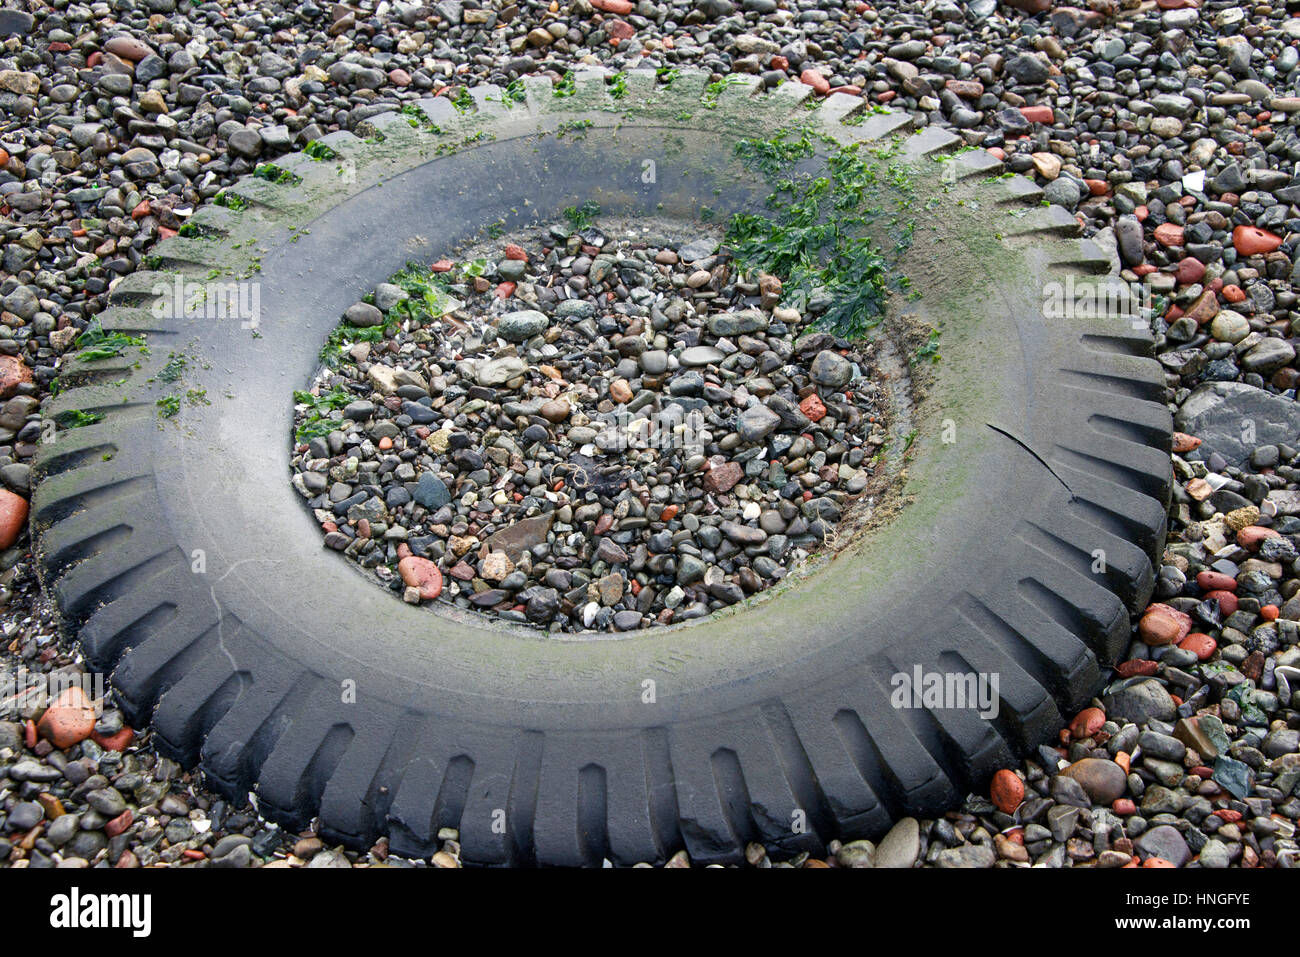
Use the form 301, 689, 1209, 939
33, 73, 1170, 865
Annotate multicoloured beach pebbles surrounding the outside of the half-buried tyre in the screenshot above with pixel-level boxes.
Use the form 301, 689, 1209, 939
0, 0, 1300, 869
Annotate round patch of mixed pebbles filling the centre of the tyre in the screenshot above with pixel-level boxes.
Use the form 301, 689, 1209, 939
291, 225, 887, 631
